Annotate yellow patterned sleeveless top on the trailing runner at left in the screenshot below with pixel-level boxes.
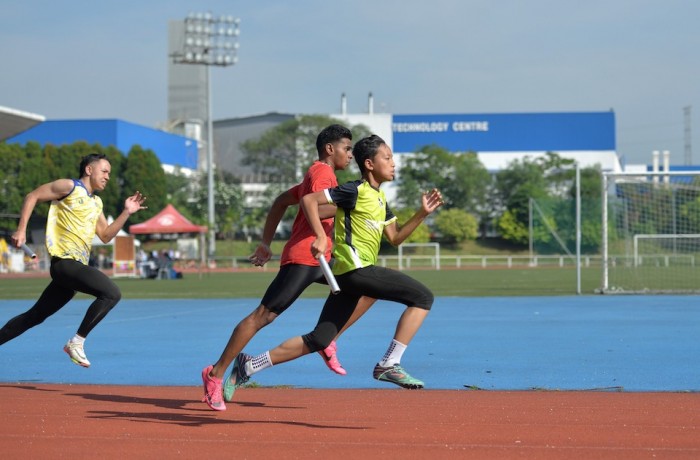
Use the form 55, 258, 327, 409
46, 179, 102, 265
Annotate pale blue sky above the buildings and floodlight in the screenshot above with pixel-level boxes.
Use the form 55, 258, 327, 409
0, 0, 700, 164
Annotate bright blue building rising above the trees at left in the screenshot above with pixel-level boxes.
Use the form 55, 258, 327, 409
7, 119, 198, 169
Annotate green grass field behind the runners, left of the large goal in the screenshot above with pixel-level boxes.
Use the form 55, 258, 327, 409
0, 268, 600, 300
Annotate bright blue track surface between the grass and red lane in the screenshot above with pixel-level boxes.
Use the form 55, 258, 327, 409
0, 296, 700, 391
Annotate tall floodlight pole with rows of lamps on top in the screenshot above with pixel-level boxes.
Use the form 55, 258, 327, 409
172, 13, 240, 264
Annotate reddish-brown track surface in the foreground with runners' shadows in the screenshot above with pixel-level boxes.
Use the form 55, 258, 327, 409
0, 383, 700, 460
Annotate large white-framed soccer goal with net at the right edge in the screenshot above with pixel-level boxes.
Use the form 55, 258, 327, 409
601, 172, 700, 294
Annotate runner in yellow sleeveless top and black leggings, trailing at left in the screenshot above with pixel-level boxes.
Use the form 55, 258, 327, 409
0, 154, 146, 367
